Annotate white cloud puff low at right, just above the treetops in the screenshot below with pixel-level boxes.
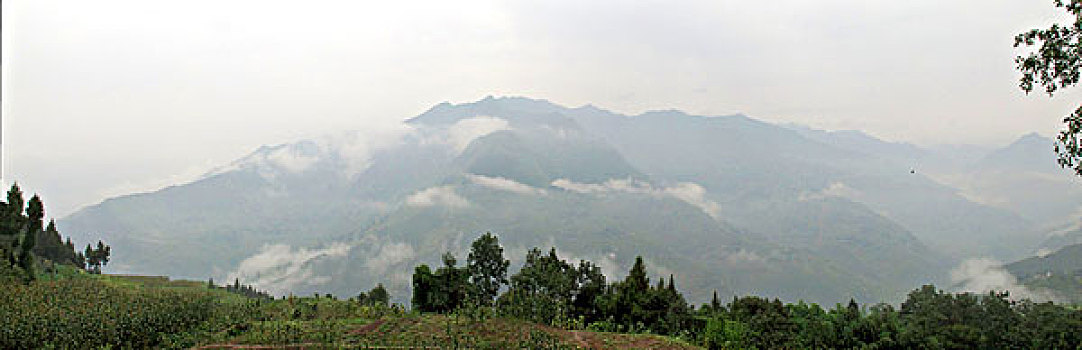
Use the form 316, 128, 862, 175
950, 258, 1055, 301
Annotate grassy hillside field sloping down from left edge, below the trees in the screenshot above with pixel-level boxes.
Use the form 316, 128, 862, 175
0, 269, 697, 349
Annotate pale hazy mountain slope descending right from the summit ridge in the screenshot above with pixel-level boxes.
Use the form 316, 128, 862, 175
558, 104, 1031, 258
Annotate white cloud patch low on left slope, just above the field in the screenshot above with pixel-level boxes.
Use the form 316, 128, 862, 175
226, 243, 351, 295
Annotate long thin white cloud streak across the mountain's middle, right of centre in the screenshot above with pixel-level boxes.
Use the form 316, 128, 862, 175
552, 179, 722, 219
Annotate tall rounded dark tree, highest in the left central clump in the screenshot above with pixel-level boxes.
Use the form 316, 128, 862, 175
466, 233, 511, 306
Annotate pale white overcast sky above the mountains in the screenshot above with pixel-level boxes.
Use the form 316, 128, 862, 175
2, 0, 1082, 217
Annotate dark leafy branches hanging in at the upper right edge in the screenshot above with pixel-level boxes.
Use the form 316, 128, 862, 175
1014, 0, 1082, 176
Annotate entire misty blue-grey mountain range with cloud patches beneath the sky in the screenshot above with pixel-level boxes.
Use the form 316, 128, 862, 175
58, 98, 1082, 303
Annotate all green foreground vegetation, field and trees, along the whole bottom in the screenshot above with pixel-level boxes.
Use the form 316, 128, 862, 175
0, 186, 1082, 349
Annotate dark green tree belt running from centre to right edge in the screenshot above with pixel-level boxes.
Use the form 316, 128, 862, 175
413, 234, 1082, 349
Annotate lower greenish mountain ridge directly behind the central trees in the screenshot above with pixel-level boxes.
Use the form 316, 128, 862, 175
317, 183, 915, 302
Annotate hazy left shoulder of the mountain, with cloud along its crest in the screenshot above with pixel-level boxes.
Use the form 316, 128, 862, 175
57, 128, 463, 278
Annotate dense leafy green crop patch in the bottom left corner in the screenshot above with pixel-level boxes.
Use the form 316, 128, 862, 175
0, 268, 216, 349
